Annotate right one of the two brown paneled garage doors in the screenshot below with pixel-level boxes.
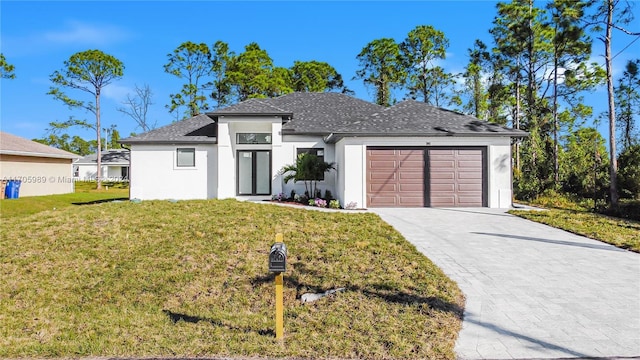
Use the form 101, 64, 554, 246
429, 149, 485, 207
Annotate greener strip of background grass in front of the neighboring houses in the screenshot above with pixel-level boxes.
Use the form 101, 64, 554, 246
0, 182, 129, 219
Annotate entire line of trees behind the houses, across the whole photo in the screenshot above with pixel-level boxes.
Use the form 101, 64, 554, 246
0, 0, 640, 201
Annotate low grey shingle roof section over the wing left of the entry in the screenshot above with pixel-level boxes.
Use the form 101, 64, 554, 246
120, 114, 216, 144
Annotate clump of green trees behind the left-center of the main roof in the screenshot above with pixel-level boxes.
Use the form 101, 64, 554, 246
164, 41, 352, 119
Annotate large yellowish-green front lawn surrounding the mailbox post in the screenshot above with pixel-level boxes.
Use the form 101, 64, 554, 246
0, 200, 464, 359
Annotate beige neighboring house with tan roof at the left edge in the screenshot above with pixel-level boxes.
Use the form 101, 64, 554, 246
0, 131, 79, 197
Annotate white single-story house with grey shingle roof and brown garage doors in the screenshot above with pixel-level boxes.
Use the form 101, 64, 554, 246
121, 93, 527, 208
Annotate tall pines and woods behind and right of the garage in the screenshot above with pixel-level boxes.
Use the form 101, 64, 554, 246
348, 0, 640, 206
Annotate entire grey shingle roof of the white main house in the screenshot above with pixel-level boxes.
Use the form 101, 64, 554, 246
121, 93, 527, 144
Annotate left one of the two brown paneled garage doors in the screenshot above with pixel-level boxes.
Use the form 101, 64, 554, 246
367, 149, 425, 207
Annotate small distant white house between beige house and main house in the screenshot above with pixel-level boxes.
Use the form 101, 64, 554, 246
73, 149, 129, 181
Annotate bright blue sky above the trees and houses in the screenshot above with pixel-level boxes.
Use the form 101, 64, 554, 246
0, 0, 640, 143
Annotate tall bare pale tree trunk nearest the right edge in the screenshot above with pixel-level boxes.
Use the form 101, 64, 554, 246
604, 0, 618, 208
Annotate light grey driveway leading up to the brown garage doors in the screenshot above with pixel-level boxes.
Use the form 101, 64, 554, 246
372, 208, 640, 359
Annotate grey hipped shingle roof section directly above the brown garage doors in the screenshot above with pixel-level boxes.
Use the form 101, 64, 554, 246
333, 100, 527, 136
